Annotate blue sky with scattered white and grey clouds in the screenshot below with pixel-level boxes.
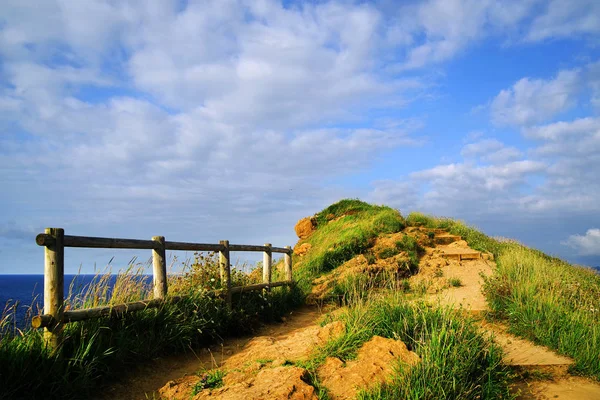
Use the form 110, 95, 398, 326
0, 0, 600, 274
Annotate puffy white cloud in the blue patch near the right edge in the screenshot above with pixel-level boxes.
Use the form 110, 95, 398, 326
491, 70, 581, 126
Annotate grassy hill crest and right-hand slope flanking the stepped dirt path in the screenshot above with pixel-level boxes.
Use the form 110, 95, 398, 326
295, 200, 600, 386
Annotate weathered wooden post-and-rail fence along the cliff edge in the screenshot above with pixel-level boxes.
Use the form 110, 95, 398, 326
32, 228, 293, 348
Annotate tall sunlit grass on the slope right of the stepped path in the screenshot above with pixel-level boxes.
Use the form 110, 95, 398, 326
485, 244, 600, 379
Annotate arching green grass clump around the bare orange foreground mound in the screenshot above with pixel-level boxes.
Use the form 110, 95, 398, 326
303, 294, 510, 399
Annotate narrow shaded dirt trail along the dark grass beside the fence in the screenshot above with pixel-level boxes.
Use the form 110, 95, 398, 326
97, 307, 322, 400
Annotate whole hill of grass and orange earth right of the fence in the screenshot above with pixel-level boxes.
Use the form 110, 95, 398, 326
156, 199, 600, 399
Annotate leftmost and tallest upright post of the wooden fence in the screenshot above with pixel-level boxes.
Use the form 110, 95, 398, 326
44, 228, 65, 351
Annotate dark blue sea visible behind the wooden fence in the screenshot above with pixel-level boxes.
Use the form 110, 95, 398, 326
0, 274, 152, 329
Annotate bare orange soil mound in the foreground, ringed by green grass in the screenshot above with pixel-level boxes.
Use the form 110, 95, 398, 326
318, 336, 420, 400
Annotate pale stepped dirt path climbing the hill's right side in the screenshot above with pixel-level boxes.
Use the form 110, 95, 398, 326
423, 234, 600, 400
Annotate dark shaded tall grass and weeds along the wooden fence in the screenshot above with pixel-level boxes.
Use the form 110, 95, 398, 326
0, 256, 303, 399
